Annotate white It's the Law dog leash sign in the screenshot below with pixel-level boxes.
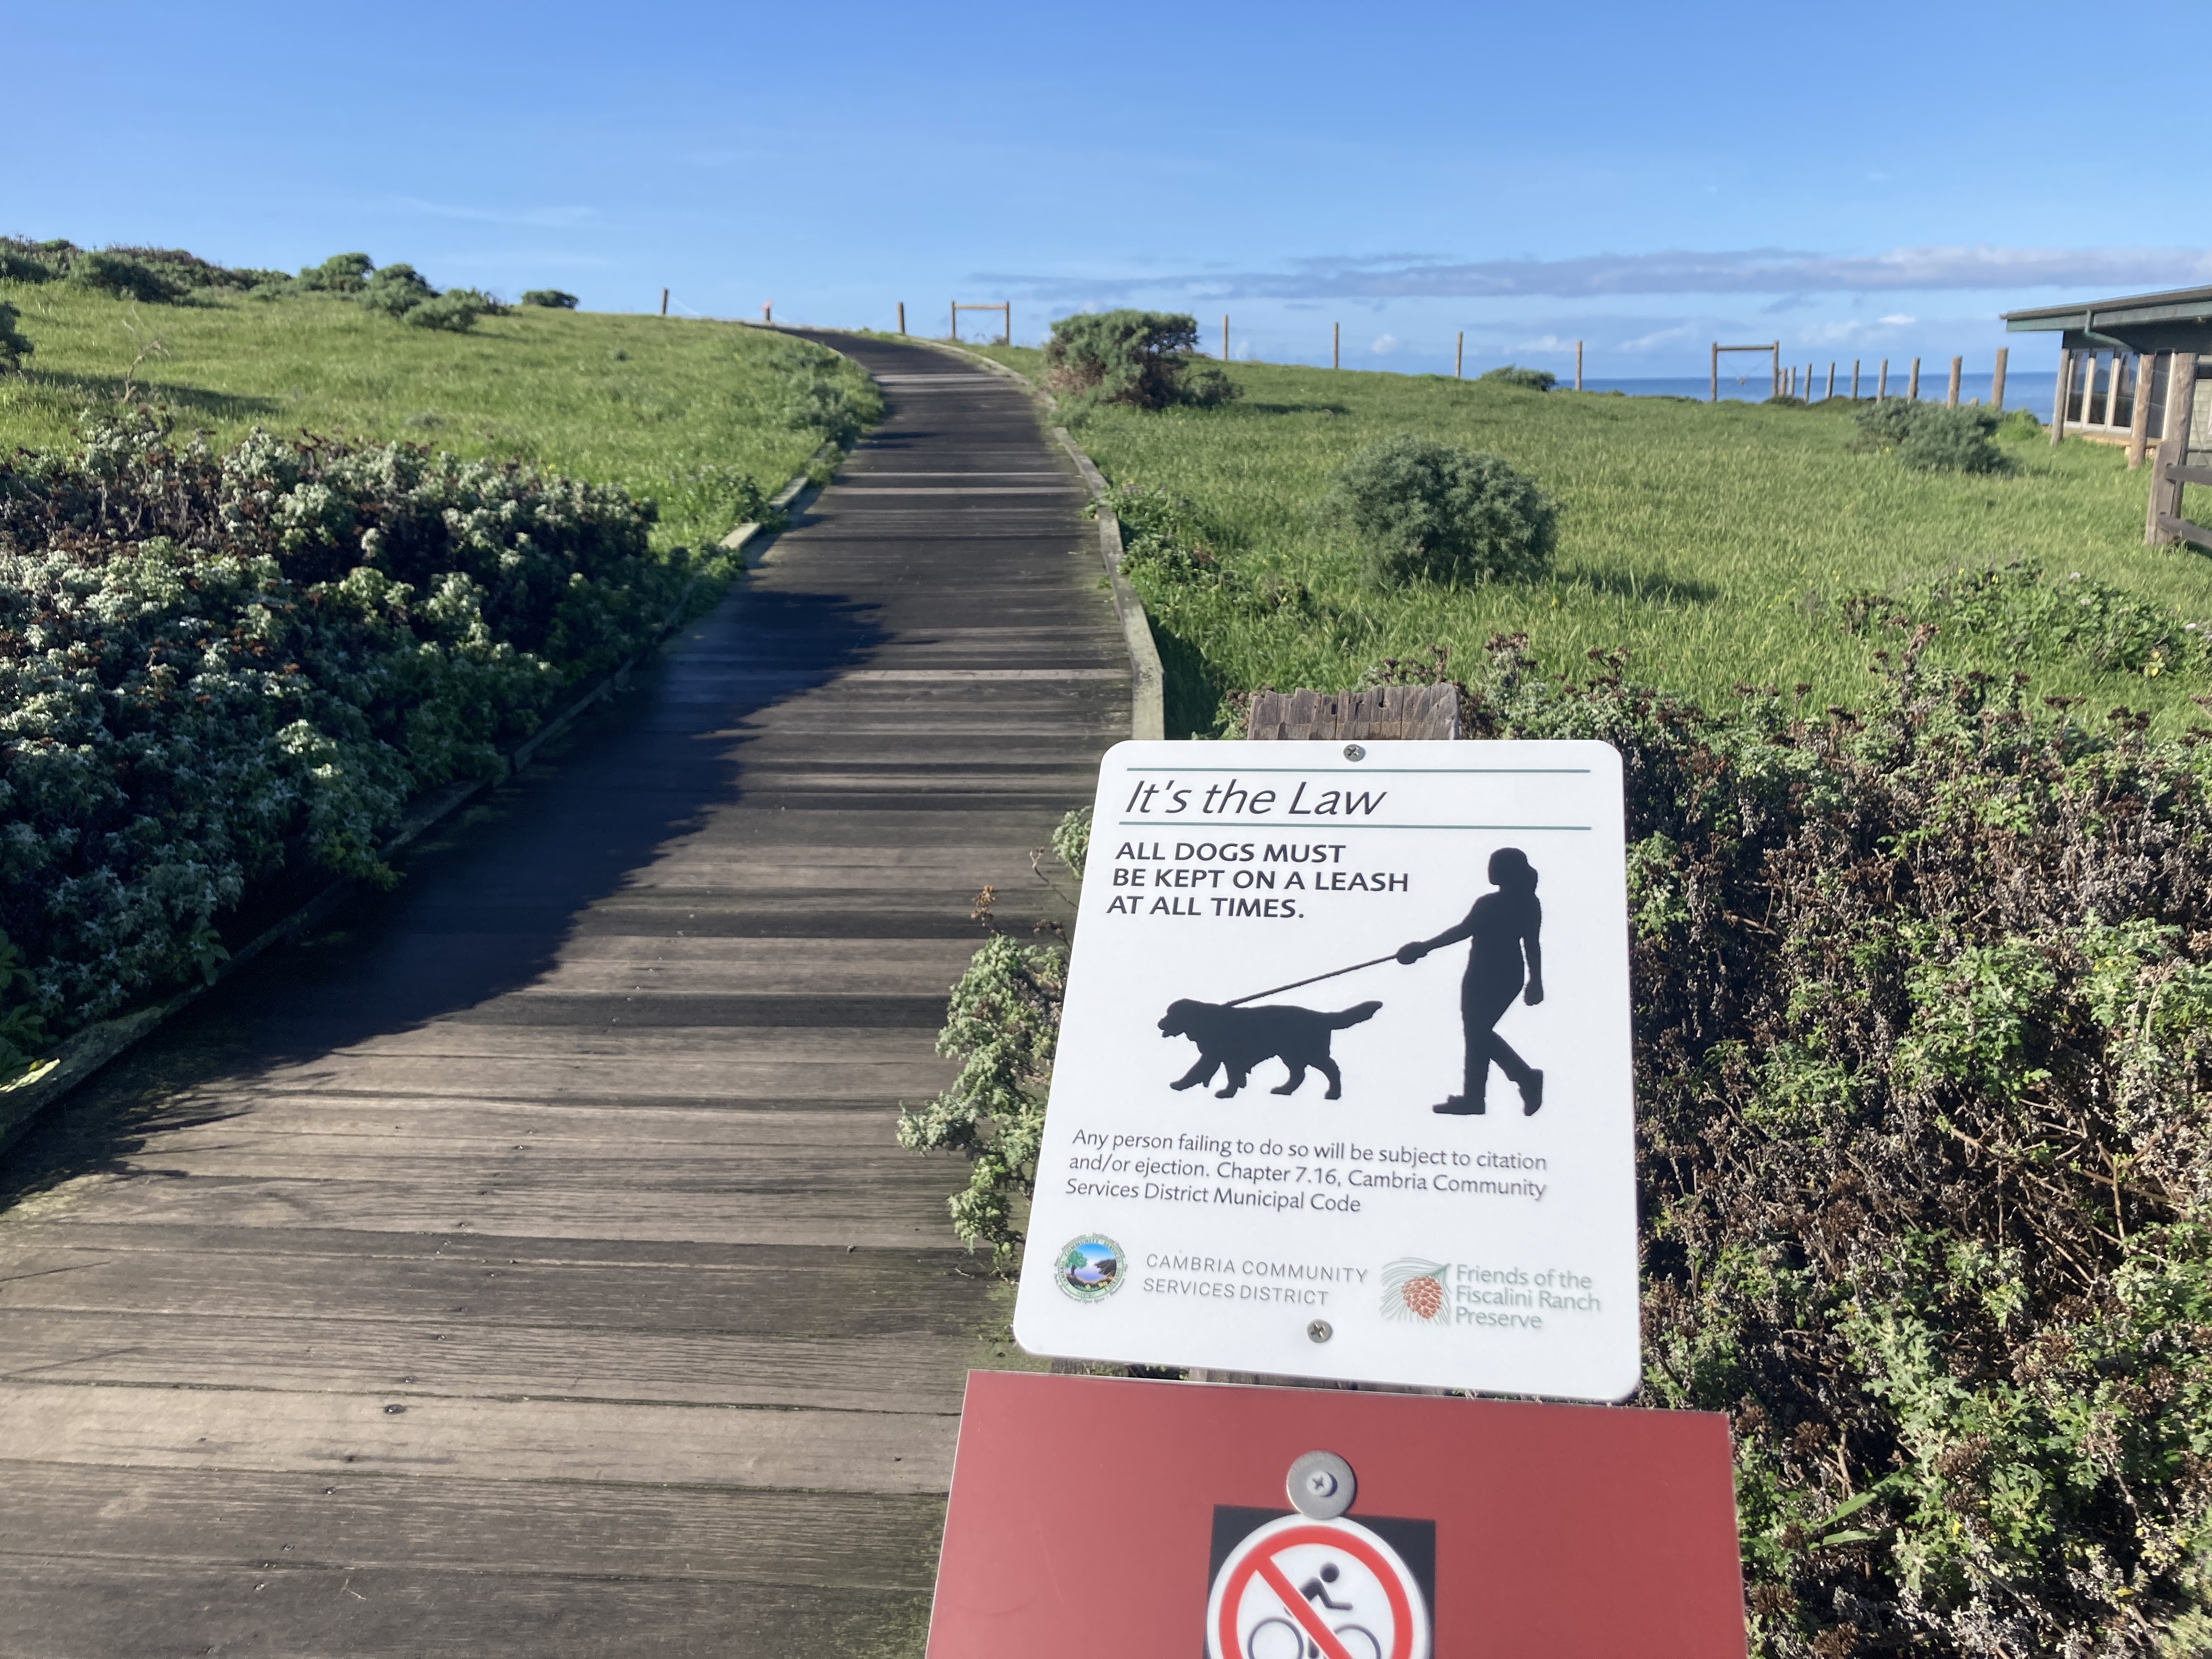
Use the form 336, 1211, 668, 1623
1013, 743, 1639, 1400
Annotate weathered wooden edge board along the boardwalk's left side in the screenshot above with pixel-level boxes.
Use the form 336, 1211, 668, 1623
0, 442, 838, 1150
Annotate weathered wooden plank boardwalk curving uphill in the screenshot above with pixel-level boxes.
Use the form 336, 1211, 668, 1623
0, 336, 1130, 1659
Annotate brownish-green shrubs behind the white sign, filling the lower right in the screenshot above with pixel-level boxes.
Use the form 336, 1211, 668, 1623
907, 624, 2212, 1659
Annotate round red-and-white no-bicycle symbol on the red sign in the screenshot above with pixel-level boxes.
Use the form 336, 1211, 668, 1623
1205, 1515, 1429, 1659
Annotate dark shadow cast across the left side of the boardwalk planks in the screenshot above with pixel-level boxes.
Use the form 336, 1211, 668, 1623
0, 582, 883, 1215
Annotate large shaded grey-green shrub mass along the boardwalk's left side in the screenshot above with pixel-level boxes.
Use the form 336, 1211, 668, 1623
0, 416, 692, 1035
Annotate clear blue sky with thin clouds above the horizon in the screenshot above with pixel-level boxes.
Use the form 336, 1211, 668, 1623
17, 0, 2212, 376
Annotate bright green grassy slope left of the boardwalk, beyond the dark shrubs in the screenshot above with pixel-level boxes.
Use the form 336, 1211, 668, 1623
0, 283, 845, 540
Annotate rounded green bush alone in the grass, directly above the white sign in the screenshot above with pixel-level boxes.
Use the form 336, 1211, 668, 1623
1321, 433, 1560, 589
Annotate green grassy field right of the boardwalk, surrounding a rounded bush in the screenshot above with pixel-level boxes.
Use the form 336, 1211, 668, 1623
955, 347, 2212, 730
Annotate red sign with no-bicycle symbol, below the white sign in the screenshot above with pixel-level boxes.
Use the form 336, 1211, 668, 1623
929, 1372, 1745, 1659
